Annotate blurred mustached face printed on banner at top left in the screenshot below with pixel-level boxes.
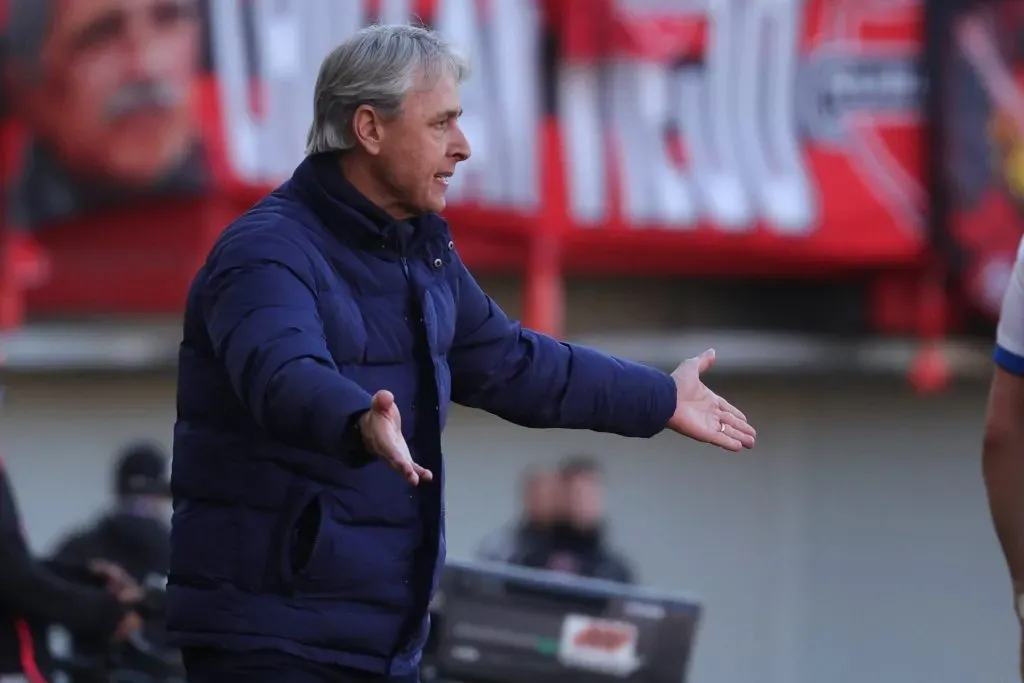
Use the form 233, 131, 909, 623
14, 0, 199, 184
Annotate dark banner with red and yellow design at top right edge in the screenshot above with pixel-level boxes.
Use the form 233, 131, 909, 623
926, 0, 1024, 319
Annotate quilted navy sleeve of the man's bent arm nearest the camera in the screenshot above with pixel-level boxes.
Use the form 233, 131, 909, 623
203, 226, 371, 460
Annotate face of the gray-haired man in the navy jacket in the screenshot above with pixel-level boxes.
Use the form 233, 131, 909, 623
377, 75, 470, 215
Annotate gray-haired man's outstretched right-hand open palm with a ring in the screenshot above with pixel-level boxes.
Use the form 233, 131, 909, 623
669, 349, 757, 451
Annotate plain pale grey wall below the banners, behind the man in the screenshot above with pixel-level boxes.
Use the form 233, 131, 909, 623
0, 375, 1017, 683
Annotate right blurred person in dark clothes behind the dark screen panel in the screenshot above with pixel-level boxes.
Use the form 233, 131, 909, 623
523, 456, 634, 584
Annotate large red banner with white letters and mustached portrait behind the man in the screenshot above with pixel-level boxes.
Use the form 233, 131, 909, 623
0, 0, 926, 319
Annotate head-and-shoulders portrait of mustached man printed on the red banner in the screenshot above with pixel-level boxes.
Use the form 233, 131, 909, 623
0, 0, 208, 227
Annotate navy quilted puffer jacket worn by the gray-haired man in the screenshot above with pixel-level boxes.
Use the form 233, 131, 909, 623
168, 156, 676, 675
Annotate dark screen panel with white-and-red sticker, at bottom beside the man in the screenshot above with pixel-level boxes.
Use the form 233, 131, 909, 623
434, 565, 700, 683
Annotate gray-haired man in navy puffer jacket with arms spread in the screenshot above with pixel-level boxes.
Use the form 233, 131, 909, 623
168, 21, 755, 683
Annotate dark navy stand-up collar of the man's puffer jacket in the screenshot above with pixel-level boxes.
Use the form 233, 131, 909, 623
290, 154, 445, 251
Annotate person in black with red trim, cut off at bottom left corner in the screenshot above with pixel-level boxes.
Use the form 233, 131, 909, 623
0, 450, 142, 683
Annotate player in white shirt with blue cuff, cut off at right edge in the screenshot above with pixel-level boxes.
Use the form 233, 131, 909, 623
982, 236, 1024, 680
